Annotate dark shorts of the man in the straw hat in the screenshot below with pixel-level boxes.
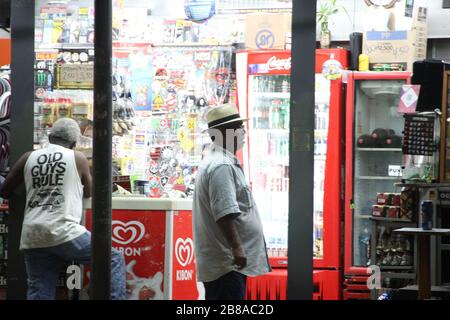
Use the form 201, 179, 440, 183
203, 271, 247, 300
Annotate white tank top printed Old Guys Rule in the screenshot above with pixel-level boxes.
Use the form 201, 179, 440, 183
20, 144, 86, 249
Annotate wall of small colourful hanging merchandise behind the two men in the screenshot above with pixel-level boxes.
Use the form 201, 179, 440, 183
34, 1, 243, 197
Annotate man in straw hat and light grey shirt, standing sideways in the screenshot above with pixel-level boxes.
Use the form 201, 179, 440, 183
193, 104, 271, 300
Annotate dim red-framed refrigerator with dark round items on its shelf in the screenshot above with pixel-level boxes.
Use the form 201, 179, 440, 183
343, 72, 411, 299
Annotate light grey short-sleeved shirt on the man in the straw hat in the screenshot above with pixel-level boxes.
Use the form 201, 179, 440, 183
192, 146, 271, 282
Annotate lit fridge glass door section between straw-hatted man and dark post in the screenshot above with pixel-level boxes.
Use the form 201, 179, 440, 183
248, 71, 290, 259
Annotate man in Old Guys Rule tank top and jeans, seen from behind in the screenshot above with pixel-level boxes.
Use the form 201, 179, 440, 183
0, 118, 126, 300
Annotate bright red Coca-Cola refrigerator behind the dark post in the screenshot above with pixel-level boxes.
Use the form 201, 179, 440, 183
236, 49, 348, 299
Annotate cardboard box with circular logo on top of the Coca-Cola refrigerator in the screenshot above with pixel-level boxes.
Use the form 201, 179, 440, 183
246, 13, 292, 49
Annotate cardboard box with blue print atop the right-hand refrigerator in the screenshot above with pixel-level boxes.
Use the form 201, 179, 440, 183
363, 7, 427, 72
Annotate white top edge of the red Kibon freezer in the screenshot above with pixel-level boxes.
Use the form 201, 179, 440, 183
83, 197, 192, 211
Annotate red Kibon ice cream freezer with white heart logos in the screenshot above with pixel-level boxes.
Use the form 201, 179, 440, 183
84, 197, 203, 300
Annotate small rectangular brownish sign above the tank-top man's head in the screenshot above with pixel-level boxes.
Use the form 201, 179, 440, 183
56, 63, 94, 89
